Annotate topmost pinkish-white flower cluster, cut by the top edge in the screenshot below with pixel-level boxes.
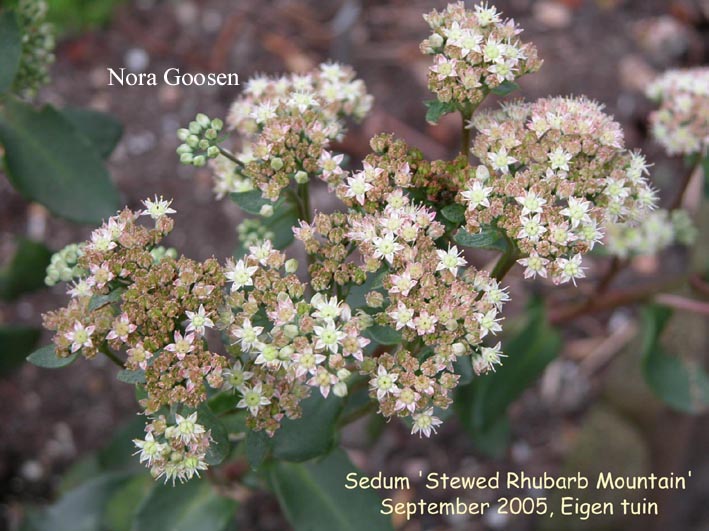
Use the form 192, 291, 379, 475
421, 2, 541, 109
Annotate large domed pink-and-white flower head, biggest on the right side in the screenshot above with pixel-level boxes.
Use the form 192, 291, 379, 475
459, 97, 655, 283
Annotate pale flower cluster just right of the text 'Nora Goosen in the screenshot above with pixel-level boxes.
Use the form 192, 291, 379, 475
216, 63, 372, 200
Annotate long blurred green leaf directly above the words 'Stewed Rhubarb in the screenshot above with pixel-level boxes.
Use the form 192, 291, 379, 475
455, 301, 562, 454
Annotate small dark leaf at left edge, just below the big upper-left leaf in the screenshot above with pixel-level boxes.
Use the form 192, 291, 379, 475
0, 238, 52, 301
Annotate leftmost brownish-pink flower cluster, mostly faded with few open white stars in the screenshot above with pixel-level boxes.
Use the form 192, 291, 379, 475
44, 199, 226, 413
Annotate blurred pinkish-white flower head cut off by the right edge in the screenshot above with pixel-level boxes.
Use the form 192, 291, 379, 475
646, 67, 709, 155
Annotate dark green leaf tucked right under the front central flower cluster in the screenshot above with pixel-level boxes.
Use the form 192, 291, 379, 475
271, 390, 343, 462
